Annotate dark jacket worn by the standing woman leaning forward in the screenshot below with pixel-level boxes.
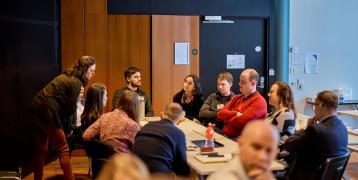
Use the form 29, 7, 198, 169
30, 74, 82, 131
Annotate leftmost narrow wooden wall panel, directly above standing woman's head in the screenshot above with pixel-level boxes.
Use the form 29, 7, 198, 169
61, 0, 84, 71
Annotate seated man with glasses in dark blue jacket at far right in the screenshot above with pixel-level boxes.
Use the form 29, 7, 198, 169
284, 91, 348, 179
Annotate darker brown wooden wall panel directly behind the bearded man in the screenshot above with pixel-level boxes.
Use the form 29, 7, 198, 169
108, 15, 151, 110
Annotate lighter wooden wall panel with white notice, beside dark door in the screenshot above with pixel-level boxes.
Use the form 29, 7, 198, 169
152, 15, 199, 115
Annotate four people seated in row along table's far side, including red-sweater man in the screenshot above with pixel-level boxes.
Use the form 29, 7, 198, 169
173, 69, 296, 139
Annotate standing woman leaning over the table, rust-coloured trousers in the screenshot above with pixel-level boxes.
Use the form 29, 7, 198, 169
30, 56, 96, 180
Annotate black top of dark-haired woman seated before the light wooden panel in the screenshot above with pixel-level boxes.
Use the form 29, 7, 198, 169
173, 90, 205, 120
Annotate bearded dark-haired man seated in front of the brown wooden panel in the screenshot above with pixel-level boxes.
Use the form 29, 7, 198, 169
112, 66, 154, 117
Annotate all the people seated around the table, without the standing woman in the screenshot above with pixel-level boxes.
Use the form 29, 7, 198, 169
68, 64, 348, 179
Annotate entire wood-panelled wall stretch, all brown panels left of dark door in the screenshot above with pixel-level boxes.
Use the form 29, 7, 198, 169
61, 4, 199, 115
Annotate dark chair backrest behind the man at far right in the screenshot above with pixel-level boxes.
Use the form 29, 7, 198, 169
321, 152, 351, 180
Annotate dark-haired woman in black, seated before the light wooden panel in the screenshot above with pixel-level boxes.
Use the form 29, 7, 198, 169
173, 74, 205, 120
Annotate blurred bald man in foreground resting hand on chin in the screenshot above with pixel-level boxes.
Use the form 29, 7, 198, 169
208, 121, 279, 180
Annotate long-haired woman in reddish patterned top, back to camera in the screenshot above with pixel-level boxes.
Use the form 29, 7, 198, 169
83, 90, 140, 152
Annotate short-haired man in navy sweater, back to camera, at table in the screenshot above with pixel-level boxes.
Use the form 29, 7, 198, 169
132, 103, 190, 176
